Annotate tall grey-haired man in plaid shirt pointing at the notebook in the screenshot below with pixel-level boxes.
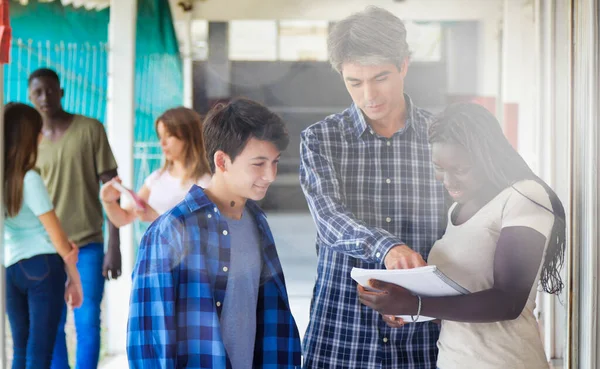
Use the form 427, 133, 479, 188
300, 7, 445, 369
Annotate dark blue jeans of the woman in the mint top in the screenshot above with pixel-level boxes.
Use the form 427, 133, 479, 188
6, 254, 66, 369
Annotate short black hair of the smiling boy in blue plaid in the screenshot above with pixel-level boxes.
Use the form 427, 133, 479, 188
204, 99, 290, 173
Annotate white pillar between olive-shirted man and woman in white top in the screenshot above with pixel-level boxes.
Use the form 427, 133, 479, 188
104, 0, 137, 354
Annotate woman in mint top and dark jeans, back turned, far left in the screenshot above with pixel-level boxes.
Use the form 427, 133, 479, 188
2, 103, 83, 369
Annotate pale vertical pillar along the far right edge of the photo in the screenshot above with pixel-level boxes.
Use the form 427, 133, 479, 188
566, 0, 600, 368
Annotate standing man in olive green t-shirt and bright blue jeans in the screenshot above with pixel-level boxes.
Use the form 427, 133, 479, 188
28, 68, 121, 369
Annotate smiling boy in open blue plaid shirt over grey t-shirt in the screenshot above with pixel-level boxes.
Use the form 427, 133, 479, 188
127, 100, 301, 369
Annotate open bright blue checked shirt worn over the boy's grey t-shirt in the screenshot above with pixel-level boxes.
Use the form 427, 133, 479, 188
127, 186, 301, 369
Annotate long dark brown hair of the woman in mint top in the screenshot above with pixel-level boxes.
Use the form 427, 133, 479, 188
4, 103, 42, 217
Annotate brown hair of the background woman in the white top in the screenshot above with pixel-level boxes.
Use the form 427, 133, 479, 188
155, 106, 211, 183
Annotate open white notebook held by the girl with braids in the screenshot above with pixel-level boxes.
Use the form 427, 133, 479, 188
350, 265, 469, 323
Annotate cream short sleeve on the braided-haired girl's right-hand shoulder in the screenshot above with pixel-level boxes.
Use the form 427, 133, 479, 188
502, 180, 554, 236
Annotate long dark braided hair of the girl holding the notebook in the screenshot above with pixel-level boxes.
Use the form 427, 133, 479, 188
429, 103, 566, 294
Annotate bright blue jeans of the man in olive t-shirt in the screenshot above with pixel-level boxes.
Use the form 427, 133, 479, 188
52, 243, 104, 369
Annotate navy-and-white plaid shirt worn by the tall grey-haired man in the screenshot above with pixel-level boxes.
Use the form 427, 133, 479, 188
300, 96, 445, 369
